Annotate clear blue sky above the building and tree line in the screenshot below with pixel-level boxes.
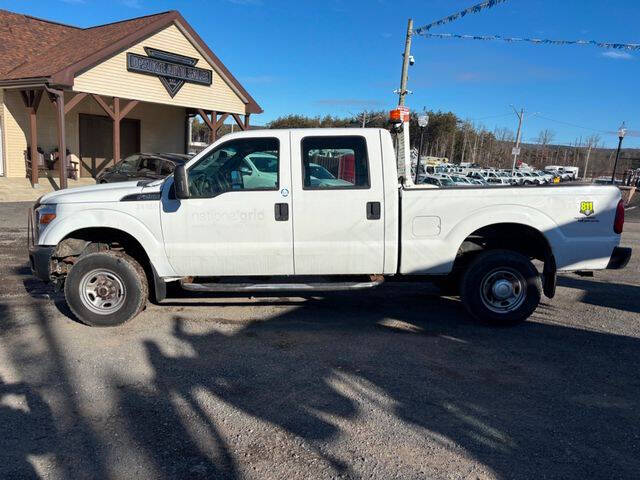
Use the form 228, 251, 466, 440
0, 0, 640, 147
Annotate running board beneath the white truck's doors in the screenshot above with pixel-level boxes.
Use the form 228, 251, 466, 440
181, 279, 384, 293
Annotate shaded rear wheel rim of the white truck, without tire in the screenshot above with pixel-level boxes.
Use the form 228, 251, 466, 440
480, 267, 527, 313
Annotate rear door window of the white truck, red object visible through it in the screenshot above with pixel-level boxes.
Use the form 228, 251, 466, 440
302, 136, 370, 190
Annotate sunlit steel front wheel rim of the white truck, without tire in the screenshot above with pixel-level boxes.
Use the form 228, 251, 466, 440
79, 269, 126, 315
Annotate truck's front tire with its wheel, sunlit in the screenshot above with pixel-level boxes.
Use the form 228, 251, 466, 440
64, 251, 149, 327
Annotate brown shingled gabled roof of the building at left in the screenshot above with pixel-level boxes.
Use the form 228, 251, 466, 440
0, 10, 262, 113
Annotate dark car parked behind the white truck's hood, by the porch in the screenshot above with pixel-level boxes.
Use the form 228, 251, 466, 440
96, 153, 193, 183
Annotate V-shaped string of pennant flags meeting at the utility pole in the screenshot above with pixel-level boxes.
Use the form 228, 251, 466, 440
412, 0, 640, 50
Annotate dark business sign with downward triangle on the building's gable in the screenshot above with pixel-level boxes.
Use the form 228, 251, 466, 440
127, 47, 213, 98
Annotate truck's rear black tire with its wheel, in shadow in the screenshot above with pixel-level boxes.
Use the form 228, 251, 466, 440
461, 250, 542, 325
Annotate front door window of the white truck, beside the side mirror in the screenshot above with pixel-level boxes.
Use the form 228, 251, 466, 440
184, 138, 280, 198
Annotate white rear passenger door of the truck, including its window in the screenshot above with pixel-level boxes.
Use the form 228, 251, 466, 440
291, 129, 385, 275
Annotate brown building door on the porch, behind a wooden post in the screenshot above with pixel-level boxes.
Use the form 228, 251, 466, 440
79, 114, 140, 178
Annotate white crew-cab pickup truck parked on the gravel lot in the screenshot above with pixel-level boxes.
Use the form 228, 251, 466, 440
29, 129, 631, 326
